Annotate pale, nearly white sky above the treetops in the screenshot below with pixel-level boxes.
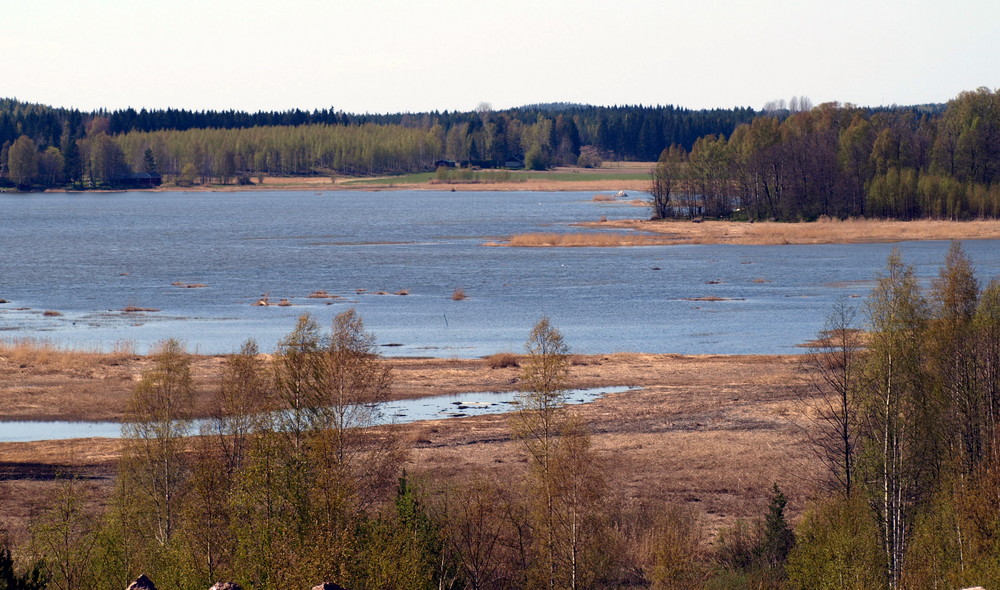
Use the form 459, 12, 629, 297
0, 0, 1000, 113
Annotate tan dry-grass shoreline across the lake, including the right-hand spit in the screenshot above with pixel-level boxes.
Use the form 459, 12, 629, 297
29, 175, 1000, 247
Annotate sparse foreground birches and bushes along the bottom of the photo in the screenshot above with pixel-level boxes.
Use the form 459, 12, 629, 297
0, 243, 1000, 590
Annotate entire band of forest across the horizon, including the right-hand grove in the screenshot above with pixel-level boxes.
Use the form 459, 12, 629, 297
0, 88, 1000, 221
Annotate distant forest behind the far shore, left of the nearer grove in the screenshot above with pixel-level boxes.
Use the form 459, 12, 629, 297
0, 99, 755, 187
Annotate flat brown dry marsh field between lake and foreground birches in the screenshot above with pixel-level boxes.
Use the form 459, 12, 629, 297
0, 342, 820, 548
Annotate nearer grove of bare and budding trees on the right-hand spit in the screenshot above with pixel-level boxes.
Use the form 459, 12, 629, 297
652, 88, 1000, 221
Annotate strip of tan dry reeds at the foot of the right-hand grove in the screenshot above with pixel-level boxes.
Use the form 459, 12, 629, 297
576, 219, 1000, 245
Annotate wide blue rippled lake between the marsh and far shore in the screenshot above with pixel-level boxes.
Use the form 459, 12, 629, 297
0, 191, 1000, 357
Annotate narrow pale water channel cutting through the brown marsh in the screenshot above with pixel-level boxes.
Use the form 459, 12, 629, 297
0, 387, 629, 443
